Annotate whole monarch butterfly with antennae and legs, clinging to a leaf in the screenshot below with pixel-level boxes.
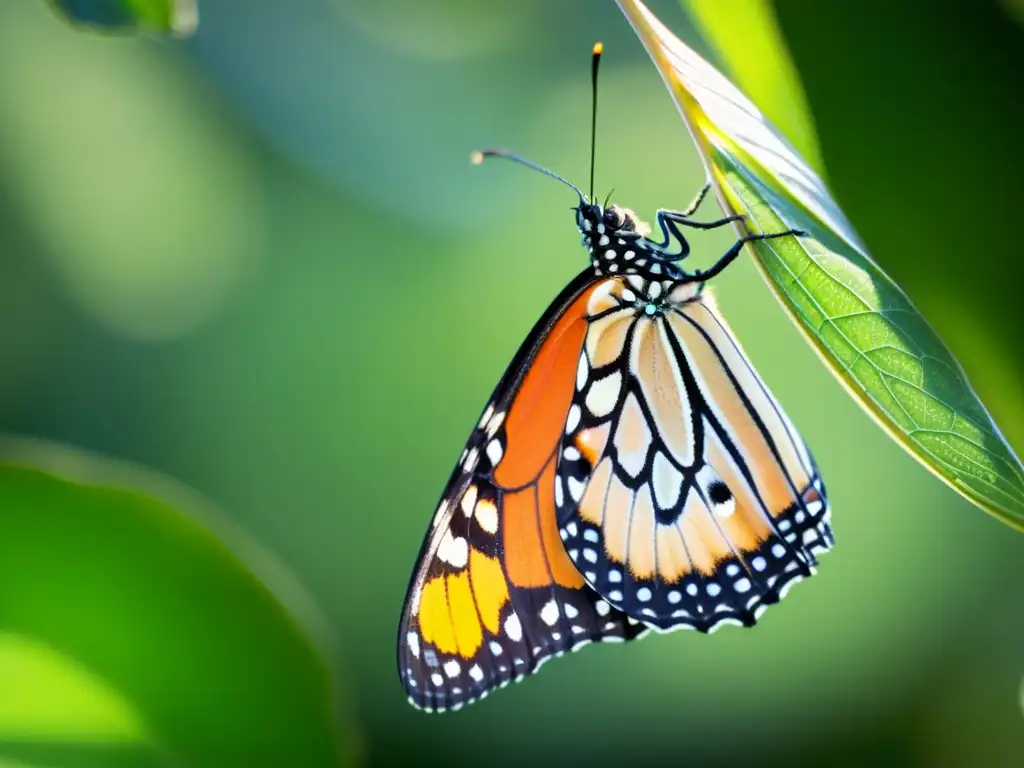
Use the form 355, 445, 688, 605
398, 44, 833, 711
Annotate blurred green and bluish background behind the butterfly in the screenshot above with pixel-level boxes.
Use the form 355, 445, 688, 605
0, 0, 1024, 766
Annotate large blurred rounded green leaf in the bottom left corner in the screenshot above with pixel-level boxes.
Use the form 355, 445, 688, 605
0, 441, 345, 768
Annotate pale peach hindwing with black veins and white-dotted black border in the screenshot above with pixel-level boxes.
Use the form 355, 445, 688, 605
555, 275, 833, 632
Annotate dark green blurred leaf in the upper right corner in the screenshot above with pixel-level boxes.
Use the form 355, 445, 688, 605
770, 0, 1024, 456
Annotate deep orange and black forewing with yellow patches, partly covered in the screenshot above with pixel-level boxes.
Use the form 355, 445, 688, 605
398, 271, 646, 712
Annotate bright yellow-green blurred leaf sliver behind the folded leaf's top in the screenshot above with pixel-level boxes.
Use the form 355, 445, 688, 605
683, 0, 823, 171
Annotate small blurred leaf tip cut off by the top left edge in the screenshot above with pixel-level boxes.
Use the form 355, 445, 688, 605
50, 0, 199, 37
